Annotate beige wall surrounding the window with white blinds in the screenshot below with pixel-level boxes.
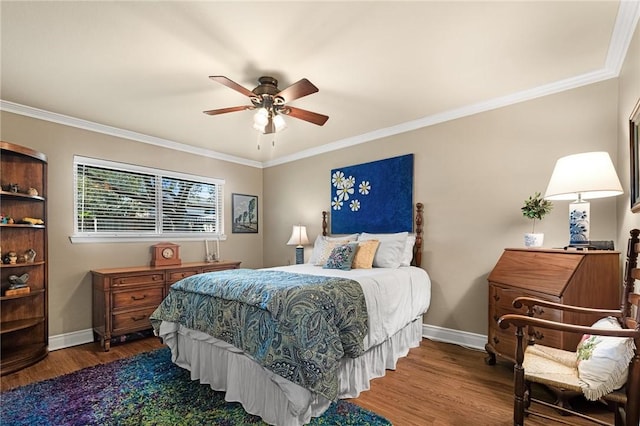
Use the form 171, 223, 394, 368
0, 112, 263, 336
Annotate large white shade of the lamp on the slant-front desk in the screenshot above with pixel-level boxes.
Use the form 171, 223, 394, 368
544, 152, 623, 200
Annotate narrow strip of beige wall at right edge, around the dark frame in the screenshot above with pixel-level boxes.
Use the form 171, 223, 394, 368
617, 26, 640, 250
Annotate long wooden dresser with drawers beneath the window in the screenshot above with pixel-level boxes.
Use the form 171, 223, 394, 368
91, 260, 240, 351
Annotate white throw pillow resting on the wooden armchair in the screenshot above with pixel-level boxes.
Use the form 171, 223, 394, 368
576, 317, 634, 401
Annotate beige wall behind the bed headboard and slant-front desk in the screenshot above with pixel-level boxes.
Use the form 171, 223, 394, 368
264, 79, 618, 334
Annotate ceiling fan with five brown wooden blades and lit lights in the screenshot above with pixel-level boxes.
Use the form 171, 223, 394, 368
204, 75, 329, 134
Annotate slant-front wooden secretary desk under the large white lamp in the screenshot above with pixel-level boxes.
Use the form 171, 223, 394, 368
485, 248, 621, 364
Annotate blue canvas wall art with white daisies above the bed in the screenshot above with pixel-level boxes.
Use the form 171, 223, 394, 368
330, 154, 413, 234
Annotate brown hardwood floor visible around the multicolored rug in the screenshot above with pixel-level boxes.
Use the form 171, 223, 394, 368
0, 337, 611, 426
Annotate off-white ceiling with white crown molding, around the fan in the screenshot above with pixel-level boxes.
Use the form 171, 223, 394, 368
0, 0, 640, 167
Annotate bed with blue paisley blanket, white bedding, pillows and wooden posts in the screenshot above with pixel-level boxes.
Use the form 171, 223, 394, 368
151, 204, 431, 426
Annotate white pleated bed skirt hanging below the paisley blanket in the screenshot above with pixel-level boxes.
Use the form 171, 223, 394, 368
159, 316, 422, 426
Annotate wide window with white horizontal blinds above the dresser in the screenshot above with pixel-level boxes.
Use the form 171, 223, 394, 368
72, 156, 224, 242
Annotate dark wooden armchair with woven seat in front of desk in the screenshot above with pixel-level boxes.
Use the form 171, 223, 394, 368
498, 229, 640, 426
